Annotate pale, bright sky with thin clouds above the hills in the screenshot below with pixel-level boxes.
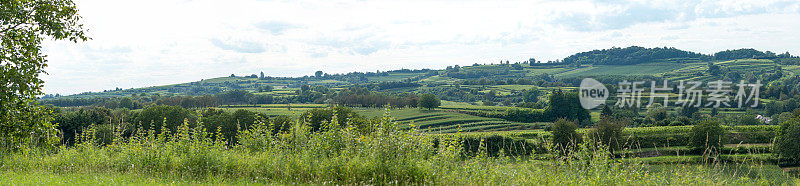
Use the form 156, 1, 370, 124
42, 0, 800, 95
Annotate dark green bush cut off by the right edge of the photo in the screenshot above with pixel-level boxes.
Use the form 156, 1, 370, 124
775, 118, 800, 164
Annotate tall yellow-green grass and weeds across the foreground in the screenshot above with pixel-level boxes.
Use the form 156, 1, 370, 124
0, 109, 790, 185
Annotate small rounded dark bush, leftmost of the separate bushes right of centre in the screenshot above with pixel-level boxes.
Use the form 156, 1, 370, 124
551, 118, 583, 155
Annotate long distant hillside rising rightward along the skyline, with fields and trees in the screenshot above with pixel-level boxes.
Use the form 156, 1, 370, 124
42, 46, 800, 99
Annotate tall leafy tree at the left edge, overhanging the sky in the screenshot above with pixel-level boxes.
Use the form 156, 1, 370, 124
0, 0, 89, 151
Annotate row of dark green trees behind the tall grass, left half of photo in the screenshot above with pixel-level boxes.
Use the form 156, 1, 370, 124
48, 105, 372, 146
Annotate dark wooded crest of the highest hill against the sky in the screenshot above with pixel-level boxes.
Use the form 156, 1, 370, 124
561, 46, 711, 65
